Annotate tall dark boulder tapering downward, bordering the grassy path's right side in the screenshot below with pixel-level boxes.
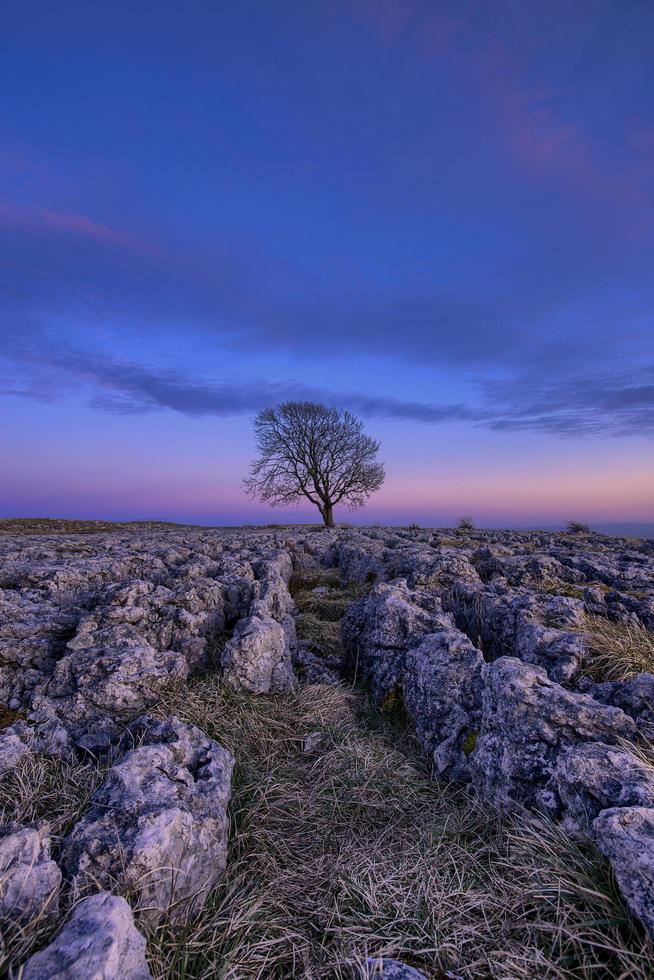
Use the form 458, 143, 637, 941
402, 629, 484, 779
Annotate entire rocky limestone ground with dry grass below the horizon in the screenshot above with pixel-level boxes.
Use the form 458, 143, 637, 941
0, 521, 654, 980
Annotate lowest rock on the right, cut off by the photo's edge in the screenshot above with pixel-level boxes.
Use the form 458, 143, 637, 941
592, 806, 654, 938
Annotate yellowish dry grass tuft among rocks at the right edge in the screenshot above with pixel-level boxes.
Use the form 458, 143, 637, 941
583, 616, 654, 681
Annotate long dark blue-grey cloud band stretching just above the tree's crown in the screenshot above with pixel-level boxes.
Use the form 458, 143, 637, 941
0, 349, 654, 437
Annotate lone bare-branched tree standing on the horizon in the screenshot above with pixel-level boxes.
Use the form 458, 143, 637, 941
244, 402, 385, 527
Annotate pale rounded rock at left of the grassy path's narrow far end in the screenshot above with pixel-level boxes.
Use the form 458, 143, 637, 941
222, 616, 295, 694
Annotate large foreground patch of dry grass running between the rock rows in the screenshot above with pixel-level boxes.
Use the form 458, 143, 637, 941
149, 679, 652, 980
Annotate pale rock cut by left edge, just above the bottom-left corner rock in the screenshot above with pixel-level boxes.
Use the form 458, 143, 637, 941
0, 823, 61, 923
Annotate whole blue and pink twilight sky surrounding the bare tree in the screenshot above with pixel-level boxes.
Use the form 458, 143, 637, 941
0, 0, 654, 526
